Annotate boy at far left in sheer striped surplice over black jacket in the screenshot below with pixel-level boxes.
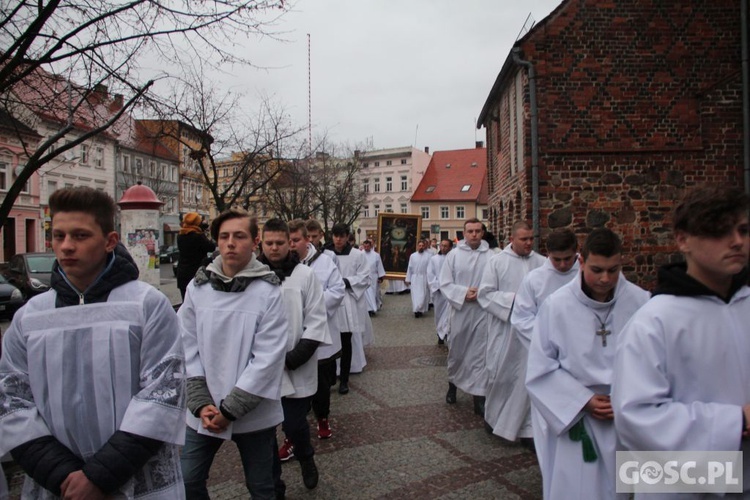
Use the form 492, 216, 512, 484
0, 187, 185, 499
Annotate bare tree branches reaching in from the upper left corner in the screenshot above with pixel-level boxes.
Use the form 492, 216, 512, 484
0, 0, 288, 224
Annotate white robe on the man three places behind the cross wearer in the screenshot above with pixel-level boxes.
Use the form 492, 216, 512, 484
439, 240, 491, 396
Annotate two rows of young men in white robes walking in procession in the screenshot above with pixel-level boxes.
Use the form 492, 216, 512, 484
0, 187, 750, 499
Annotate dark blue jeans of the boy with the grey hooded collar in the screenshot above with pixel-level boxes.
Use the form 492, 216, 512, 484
180, 427, 276, 500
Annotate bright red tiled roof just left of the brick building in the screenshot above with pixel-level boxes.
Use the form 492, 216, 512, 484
411, 148, 489, 203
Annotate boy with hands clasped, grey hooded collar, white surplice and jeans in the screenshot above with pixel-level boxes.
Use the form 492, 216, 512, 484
178, 209, 289, 499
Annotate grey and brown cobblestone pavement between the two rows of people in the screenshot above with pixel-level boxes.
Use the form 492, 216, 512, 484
2, 284, 542, 500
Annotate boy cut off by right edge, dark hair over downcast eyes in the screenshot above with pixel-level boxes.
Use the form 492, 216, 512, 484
612, 187, 750, 497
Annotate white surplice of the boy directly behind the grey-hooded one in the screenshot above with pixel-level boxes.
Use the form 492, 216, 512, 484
281, 264, 331, 398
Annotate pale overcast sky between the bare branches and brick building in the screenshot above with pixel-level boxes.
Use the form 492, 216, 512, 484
206, 0, 561, 151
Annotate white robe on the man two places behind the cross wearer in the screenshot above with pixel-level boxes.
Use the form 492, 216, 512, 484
478, 245, 545, 441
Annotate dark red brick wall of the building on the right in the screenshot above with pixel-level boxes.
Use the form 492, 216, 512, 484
485, 0, 743, 288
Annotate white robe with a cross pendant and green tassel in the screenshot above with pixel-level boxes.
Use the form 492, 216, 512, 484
526, 272, 649, 500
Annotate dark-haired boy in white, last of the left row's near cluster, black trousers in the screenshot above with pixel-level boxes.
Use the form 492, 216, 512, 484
326, 223, 372, 394
